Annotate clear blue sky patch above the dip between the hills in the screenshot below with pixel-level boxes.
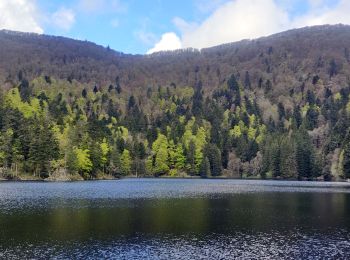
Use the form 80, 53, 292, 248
38, 0, 204, 53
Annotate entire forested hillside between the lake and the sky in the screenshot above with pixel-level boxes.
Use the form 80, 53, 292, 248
0, 25, 350, 180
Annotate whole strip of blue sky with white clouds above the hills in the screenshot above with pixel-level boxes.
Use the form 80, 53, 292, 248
0, 0, 350, 54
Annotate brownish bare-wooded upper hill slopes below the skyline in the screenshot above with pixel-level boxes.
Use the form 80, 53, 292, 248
0, 25, 350, 95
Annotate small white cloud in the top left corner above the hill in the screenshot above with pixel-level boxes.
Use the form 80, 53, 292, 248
0, 0, 44, 33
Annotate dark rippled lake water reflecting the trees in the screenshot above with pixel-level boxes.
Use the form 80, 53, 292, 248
0, 179, 350, 259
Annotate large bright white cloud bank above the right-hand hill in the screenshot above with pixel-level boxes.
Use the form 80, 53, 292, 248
149, 0, 350, 52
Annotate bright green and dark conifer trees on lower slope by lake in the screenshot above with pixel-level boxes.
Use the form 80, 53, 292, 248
0, 72, 350, 180
